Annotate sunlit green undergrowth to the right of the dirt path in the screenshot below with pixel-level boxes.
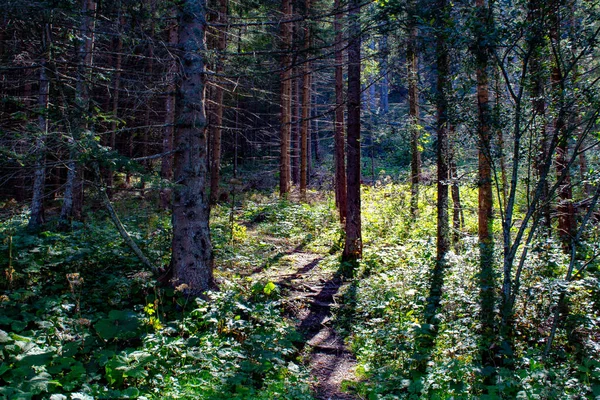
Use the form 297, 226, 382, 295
336, 183, 600, 399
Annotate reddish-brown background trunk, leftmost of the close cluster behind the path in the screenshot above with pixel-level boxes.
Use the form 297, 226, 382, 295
279, 0, 292, 197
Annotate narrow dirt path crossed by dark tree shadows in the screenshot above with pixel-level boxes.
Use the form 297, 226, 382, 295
246, 237, 360, 400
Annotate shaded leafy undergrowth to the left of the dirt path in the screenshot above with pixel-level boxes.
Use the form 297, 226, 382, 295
0, 204, 312, 400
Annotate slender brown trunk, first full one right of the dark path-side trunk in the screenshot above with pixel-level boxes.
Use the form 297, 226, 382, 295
406, 8, 421, 219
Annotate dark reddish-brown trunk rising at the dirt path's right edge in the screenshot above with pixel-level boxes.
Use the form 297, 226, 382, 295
342, 0, 362, 263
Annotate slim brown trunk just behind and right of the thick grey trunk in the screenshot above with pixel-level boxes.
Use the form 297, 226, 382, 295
210, 0, 228, 204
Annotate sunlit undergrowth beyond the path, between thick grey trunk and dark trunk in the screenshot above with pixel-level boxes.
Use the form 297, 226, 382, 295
211, 193, 342, 275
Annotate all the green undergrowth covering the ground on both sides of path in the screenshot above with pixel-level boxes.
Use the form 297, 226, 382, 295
0, 181, 600, 400
